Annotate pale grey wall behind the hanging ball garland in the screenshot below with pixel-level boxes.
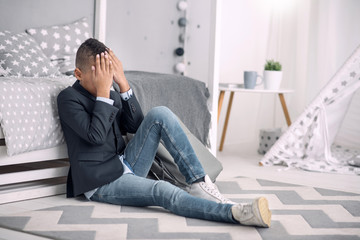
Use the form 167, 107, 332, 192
106, 0, 213, 83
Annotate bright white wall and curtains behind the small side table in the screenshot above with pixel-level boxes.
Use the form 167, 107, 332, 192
218, 0, 360, 151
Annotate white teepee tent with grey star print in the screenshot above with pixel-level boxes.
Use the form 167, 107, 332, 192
261, 46, 360, 174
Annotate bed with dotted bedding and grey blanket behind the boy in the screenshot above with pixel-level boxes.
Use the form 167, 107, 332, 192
0, 71, 214, 204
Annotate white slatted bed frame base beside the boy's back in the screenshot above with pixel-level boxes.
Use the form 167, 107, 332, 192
0, 126, 69, 204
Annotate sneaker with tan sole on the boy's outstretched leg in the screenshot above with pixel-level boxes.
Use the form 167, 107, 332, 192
231, 197, 271, 228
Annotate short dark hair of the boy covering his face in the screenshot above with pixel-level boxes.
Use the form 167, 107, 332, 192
75, 38, 108, 71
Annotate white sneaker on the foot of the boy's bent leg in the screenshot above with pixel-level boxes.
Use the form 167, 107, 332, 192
189, 175, 236, 204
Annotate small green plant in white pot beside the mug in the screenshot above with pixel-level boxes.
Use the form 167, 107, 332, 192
264, 59, 282, 90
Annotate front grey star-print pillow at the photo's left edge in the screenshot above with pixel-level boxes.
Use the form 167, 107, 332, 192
0, 31, 59, 77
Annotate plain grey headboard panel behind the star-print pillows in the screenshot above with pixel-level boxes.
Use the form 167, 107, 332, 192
0, 0, 96, 36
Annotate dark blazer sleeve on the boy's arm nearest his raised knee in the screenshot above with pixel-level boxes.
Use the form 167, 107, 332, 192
119, 94, 144, 133
